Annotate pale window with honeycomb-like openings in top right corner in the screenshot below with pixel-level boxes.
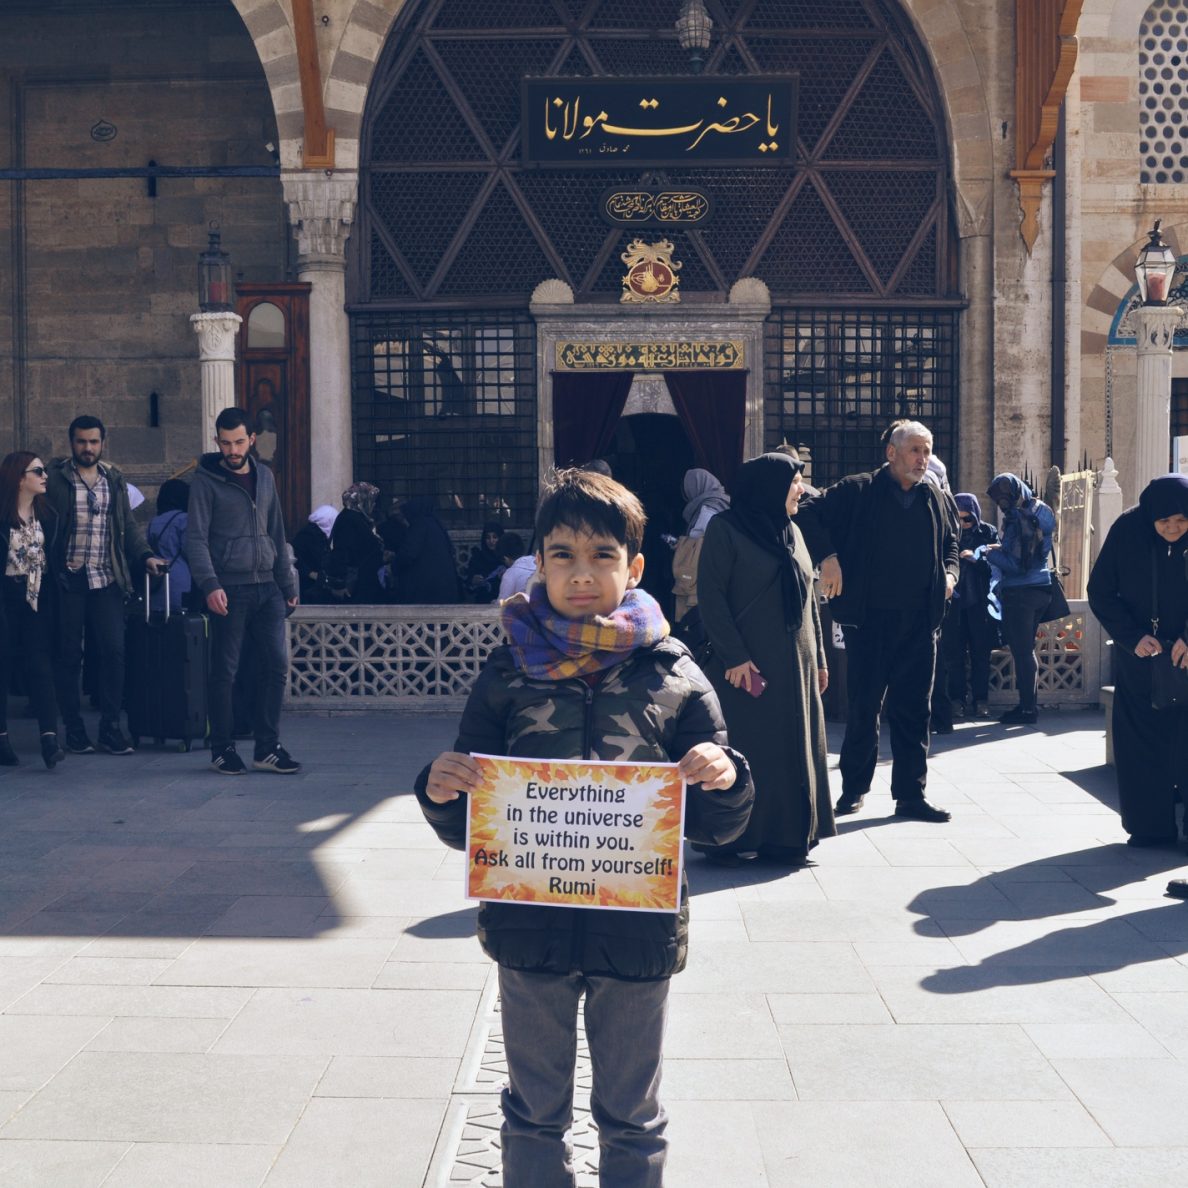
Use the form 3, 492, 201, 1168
1138, 0, 1188, 183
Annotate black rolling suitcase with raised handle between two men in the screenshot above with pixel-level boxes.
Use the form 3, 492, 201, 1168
124, 570, 210, 751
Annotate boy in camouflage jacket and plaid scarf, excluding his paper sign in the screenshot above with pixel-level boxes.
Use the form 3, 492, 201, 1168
417, 470, 754, 1188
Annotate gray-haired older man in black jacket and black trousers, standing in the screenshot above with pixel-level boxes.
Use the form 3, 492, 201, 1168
803, 422, 960, 821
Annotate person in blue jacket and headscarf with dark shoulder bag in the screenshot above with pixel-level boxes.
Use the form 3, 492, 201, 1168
984, 472, 1056, 725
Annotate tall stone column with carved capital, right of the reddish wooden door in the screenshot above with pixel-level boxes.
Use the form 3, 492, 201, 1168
283, 172, 356, 507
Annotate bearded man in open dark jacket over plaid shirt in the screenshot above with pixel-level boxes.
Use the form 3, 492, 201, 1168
46, 416, 165, 754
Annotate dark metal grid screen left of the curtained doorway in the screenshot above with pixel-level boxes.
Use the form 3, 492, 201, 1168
352, 311, 536, 527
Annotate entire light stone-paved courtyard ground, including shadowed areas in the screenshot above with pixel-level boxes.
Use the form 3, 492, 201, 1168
0, 713, 1188, 1188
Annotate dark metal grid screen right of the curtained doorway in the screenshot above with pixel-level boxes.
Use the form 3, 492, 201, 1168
764, 309, 959, 486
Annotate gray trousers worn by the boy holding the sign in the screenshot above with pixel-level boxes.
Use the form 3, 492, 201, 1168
499, 966, 669, 1188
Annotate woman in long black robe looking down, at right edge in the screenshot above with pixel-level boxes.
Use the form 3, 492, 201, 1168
1088, 474, 1188, 847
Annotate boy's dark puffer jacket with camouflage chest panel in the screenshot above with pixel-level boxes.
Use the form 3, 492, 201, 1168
417, 638, 754, 980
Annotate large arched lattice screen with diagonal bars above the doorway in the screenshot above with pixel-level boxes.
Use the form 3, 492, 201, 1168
352, 0, 955, 307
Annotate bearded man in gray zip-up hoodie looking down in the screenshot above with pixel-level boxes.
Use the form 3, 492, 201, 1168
185, 409, 301, 776
